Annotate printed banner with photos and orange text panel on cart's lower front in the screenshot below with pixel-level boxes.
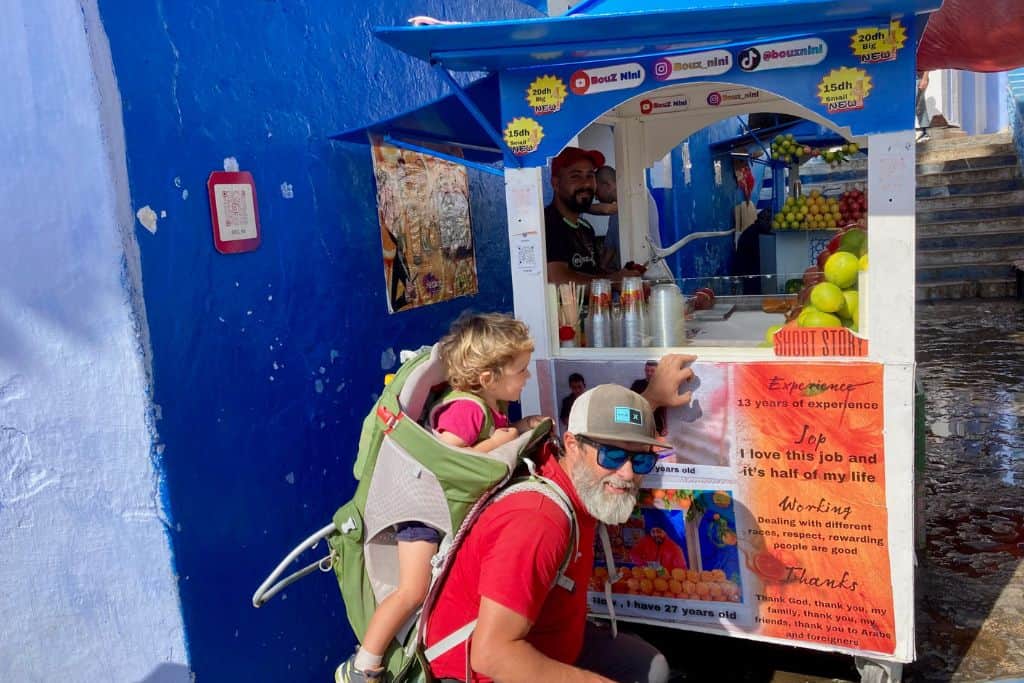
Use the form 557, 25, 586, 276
550, 360, 912, 655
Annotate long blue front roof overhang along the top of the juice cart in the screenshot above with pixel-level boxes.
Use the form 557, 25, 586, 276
375, 0, 942, 72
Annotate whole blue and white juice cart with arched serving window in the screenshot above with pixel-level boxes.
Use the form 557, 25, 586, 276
340, 0, 941, 680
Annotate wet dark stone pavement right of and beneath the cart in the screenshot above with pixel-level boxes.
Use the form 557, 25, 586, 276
643, 299, 1024, 683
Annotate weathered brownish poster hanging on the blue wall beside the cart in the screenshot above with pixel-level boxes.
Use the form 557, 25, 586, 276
371, 137, 477, 313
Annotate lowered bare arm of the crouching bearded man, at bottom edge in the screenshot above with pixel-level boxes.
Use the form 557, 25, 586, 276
469, 597, 611, 683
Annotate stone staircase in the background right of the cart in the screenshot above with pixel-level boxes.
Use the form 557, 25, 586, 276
916, 132, 1024, 301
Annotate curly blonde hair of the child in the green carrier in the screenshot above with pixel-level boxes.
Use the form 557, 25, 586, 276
438, 313, 534, 393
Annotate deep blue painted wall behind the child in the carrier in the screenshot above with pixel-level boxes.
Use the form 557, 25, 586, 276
99, 0, 535, 681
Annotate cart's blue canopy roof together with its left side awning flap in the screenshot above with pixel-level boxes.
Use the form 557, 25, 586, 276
334, 0, 942, 158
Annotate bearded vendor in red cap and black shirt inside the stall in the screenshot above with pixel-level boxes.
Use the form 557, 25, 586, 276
544, 147, 642, 284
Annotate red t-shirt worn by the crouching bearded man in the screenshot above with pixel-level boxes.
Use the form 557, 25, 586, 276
426, 450, 597, 683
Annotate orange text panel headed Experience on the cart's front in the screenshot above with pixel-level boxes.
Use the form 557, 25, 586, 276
734, 364, 896, 654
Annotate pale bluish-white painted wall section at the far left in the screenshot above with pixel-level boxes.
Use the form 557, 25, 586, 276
0, 0, 188, 682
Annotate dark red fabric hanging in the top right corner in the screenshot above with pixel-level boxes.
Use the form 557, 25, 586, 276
918, 0, 1024, 72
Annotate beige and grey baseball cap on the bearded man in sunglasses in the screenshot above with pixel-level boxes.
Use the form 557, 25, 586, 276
566, 384, 666, 447
